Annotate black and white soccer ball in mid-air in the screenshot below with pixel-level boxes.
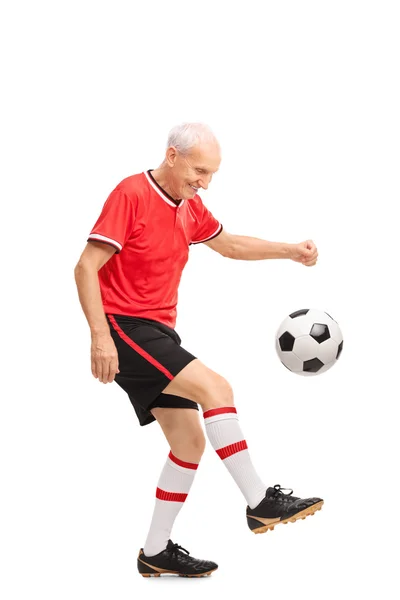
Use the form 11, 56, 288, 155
275, 308, 343, 375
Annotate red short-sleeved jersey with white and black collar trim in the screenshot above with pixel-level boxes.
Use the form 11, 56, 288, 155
87, 171, 222, 329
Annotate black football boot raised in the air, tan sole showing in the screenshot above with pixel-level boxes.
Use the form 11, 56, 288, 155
246, 485, 324, 533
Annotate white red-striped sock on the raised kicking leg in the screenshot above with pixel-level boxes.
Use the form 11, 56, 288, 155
203, 406, 267, 508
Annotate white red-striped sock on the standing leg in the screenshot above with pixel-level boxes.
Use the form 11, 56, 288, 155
143, 452, 199, 556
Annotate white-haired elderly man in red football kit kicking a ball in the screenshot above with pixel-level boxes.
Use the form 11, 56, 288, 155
75, 123, 323, 577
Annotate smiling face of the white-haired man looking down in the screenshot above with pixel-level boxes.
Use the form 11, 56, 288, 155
167, 143, 221, 200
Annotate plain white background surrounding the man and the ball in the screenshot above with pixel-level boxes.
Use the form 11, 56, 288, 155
0, 0, 400, 600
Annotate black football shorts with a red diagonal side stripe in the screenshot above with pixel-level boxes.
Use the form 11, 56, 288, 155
106, 314, 199, 425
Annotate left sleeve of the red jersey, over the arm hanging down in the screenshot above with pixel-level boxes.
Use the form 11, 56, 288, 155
87, 187, 136, 254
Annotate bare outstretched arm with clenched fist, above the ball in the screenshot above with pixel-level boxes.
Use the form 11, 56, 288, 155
204, 229, 318, 266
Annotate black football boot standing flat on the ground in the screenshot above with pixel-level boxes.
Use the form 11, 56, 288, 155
137, 540, 218, 577
